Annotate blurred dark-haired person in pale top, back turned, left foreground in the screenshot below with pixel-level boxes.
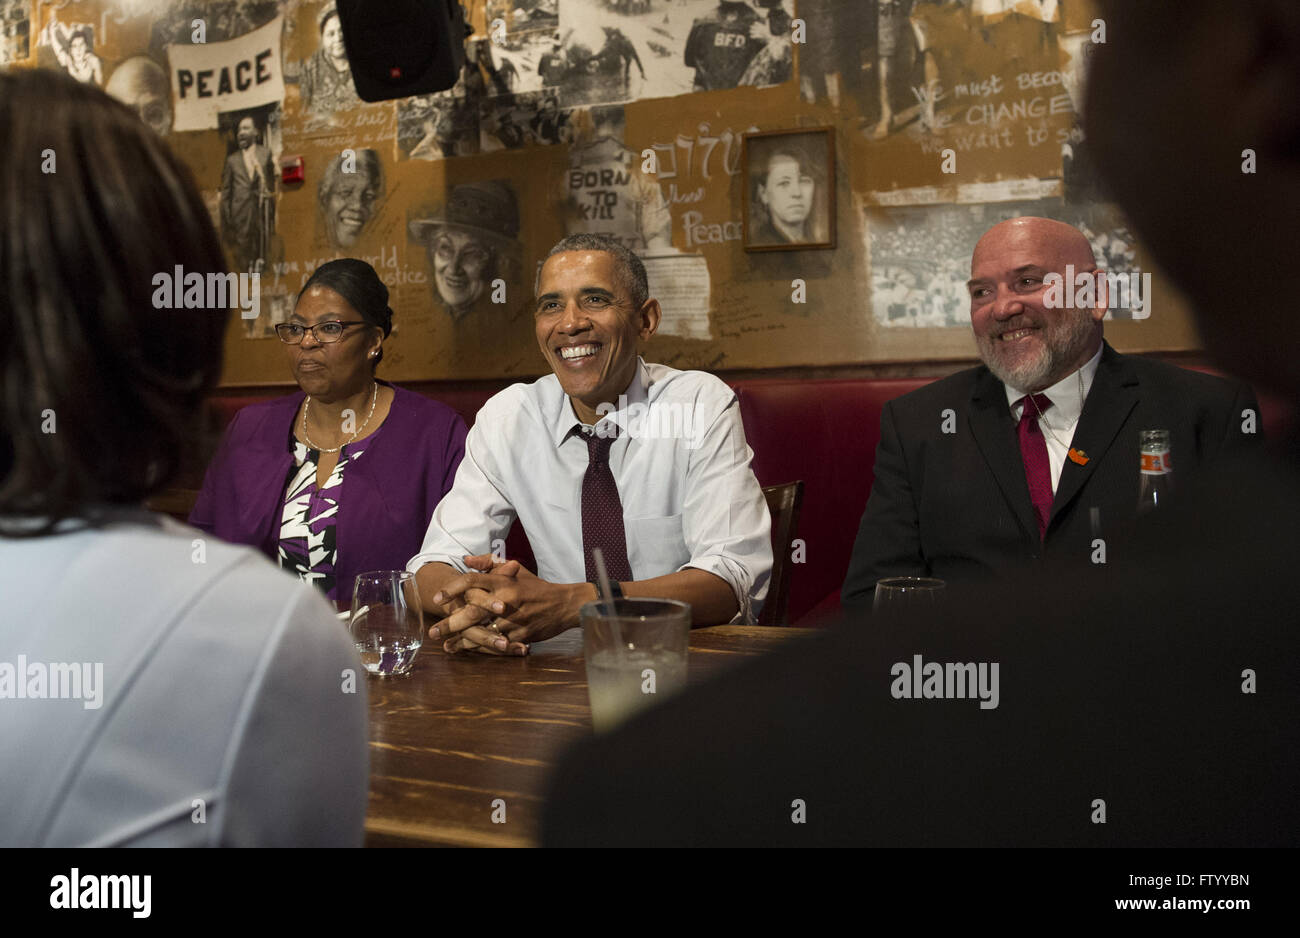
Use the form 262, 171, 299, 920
0, 70, 368, 846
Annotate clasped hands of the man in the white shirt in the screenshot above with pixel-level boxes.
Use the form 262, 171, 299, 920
429, 553, 592, 655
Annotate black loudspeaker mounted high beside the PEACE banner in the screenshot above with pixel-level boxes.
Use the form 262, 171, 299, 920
338, 0, 469, 101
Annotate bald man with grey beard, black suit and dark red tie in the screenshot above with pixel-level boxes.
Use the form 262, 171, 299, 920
841, 217, 1261, 605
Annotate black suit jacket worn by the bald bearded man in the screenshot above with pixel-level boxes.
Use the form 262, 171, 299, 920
841, 344, 1262, 604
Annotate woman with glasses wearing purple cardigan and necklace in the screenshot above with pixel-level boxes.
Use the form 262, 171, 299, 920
190, 257, 465, 603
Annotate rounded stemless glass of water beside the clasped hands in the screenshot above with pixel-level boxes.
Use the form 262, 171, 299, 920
347, 570, 424, 677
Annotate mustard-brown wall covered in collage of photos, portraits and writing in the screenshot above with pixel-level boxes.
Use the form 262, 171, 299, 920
0, 0, 1195, 386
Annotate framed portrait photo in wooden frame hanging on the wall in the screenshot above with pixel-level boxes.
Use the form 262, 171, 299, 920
741, 127, 835, 251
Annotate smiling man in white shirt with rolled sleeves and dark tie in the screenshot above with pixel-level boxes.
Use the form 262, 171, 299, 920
407, 235, 772, 655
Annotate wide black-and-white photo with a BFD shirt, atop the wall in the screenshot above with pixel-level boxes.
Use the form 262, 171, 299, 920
551, 0, 793, 107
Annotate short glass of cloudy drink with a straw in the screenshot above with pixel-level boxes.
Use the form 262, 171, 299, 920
580, 599, 690, 733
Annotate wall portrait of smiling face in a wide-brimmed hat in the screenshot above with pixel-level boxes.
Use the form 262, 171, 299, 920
407, 179, 520, 323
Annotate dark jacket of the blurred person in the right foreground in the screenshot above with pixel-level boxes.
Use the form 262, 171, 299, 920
542, 433, 1300, 847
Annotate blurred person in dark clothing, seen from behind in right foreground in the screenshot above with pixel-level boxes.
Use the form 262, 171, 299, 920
543, 0, 1300, 846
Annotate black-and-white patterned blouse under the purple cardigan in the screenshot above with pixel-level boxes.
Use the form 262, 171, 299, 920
278, 431, 378, 600
